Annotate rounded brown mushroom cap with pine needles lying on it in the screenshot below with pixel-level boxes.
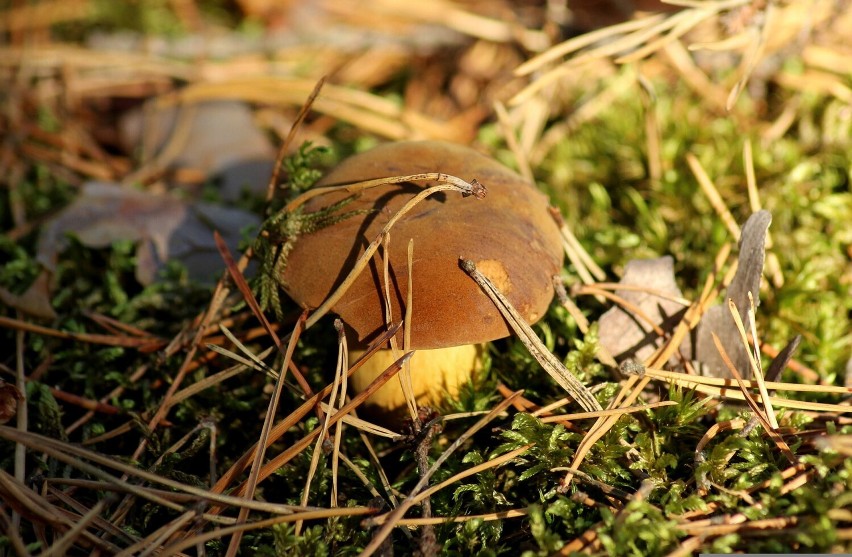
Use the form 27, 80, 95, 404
283, 141, 562, 349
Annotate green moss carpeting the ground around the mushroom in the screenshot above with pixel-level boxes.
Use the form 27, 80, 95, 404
0, 2, 852, 555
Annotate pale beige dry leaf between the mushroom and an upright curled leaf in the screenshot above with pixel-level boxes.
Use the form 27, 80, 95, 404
599, 256, 689, 361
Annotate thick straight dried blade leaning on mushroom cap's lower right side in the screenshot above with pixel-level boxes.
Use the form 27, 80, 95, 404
460, 259, 602, 412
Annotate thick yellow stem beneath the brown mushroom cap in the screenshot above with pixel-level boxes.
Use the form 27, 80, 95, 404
349, 344, 484, 414
